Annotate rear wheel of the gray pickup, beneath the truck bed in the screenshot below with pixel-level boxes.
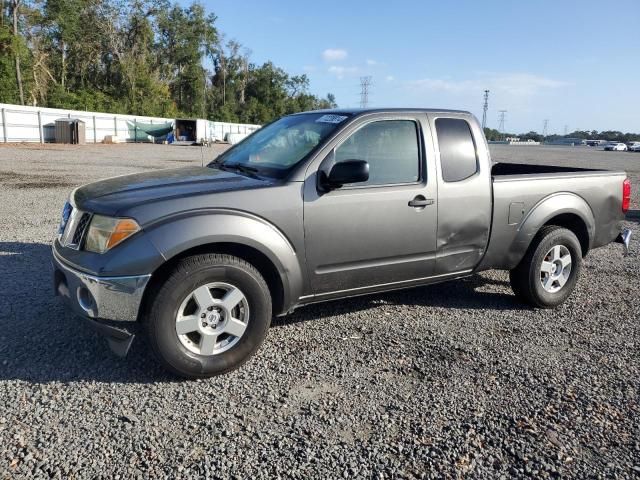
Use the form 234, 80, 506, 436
509, 225, 582, 308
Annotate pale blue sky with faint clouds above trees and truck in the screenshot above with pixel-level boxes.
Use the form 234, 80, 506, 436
181, 0, 640, 134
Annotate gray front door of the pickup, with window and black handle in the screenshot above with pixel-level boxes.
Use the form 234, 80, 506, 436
304, 115, 437, 295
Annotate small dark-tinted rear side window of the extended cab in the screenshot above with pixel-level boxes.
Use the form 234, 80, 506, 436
436, 118, 478, 182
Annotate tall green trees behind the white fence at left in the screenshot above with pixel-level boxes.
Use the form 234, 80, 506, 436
0, 0, 336, 123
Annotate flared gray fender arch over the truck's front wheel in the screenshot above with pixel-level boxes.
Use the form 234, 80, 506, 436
144, 210, 304, 309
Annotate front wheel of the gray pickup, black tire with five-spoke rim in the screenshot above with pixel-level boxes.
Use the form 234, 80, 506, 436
146, 254, 272, 379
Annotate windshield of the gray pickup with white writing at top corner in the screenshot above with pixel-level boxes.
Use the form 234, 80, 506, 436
208, 113, 348, 178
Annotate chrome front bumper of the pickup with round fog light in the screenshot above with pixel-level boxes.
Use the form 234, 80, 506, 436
53, 250, 151, 356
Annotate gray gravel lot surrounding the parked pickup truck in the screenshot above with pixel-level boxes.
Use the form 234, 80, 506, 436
0, 145, 640, 478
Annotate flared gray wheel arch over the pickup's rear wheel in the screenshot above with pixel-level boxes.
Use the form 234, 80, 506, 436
507, 192, 596, 268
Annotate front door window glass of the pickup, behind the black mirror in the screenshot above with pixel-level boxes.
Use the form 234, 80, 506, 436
335, 120, 420, 186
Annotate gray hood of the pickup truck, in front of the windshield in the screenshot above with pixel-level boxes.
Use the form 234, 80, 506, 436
73, 167, 273, 215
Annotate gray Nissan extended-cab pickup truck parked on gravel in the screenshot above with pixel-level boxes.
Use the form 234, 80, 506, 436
53, 109, 630, 378
